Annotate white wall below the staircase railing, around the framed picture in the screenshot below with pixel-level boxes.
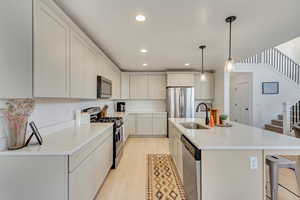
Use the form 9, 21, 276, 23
235, 64, 300, 127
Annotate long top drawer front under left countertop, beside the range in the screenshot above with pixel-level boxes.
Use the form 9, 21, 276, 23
69, 127, 113, 172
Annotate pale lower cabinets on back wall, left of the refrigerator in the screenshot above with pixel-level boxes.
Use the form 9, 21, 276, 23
125, 112, 167, 137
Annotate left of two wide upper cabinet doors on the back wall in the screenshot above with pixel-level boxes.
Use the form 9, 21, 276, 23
130, 75, 148, 99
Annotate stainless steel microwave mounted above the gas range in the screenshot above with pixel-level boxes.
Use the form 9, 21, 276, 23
97, 76, 112, 99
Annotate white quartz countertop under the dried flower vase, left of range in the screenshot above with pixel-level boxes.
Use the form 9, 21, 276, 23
0, 123, 113, 156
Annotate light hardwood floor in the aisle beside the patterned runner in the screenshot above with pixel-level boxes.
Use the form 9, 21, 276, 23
96, 138, 169, 200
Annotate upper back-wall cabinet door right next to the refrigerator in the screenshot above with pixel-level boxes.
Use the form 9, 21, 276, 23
148, 74, 166, 99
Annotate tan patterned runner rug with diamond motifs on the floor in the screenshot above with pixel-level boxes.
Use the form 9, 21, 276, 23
146, 154, 187, 200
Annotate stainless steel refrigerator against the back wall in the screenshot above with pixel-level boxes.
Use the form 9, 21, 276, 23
167, 87, 195, 118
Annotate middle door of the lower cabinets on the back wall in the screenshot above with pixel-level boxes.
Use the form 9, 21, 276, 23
136, 114, 153, 135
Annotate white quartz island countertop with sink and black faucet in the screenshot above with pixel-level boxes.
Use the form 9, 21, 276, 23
169, 118, 300, 150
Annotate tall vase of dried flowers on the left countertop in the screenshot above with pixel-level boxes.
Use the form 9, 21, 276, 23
3, 99, 34, 150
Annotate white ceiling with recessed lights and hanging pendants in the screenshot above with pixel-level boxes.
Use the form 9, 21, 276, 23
56, 0, 300, 71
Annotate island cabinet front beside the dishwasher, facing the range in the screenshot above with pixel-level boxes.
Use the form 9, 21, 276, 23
169, 123, 183, 180
